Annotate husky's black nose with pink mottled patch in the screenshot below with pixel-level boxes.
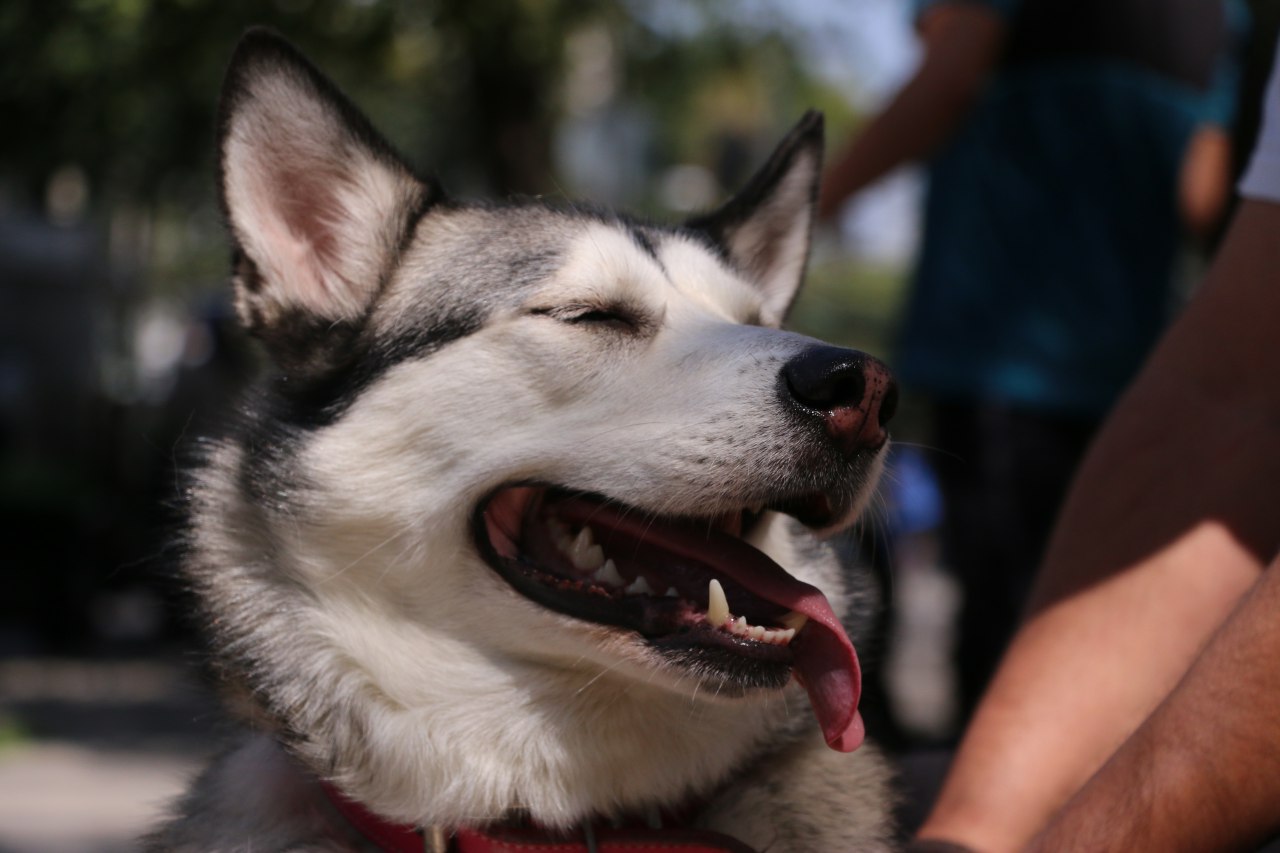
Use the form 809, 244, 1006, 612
782, 346, 897, 453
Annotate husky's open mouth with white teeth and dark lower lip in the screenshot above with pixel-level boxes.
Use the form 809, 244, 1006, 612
474, 484, 855, 697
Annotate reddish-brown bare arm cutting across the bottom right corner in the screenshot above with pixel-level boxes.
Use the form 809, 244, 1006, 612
1029, 545, 1280, 853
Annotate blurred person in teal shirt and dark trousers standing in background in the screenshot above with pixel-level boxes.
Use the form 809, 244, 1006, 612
820, 0, 1245, 717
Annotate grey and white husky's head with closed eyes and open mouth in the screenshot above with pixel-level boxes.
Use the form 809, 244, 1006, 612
197, 32, 895, 819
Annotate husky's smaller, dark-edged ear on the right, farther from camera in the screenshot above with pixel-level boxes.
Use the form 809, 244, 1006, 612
686, 110, 823, 325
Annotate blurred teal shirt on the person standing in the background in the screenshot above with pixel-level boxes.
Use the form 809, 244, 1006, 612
895, 0, 1238, 416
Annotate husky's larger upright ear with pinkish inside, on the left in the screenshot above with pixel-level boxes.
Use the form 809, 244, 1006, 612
219, 28, 439, 366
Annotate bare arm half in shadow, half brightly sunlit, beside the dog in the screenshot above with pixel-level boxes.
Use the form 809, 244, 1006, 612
919, 201, 1280, 852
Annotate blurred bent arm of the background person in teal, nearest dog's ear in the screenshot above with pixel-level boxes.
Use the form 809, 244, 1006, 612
818, 3, 1006, 219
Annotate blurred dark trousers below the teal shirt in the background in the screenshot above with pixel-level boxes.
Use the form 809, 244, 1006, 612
933, 401, 1098, 722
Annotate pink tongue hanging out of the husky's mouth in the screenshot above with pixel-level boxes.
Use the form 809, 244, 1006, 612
557, 502, 865, 752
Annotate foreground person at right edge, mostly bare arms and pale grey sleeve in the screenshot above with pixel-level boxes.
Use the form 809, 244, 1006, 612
918, 43, 1280, 853
